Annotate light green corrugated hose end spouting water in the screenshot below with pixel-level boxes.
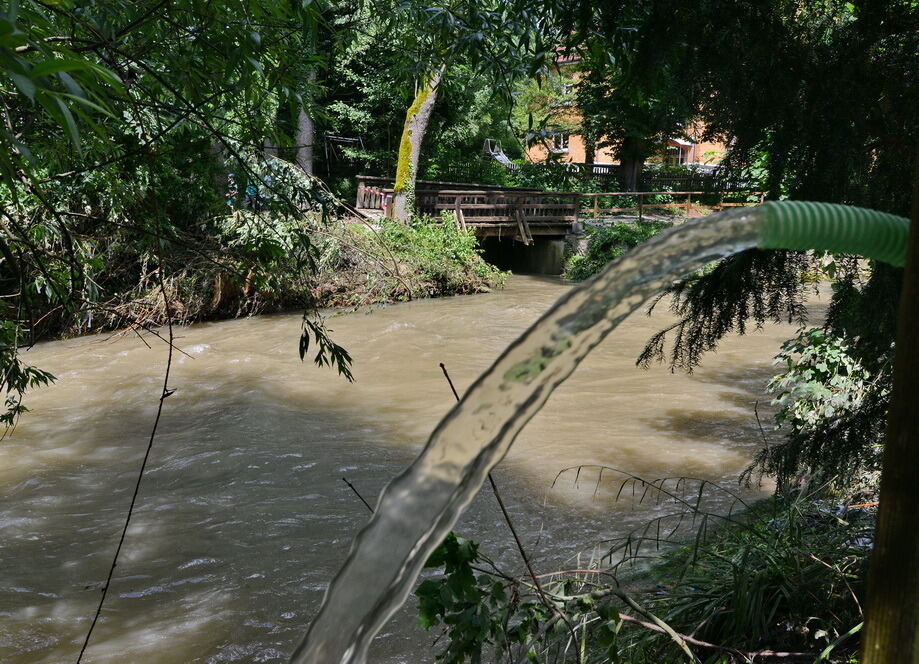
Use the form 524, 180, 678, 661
758, 201, 909, 267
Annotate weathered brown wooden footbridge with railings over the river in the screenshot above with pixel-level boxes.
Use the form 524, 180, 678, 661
357, 176, 762, 244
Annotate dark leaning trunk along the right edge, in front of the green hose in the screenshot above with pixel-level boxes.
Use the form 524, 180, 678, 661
862, 149, 919, 664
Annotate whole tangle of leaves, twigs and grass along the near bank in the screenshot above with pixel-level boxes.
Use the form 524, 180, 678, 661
416, 478, 874, 664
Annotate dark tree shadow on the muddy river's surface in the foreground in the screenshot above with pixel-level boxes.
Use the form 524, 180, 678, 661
0, 369, 620, 664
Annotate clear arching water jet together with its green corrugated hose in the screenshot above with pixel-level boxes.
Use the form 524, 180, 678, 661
291, 203, 909, 664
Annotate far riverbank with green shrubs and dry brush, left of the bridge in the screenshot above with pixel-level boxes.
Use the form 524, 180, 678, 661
60, 215, 507, 337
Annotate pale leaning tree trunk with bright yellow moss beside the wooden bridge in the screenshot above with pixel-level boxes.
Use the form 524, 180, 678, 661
392, 69, 443, 221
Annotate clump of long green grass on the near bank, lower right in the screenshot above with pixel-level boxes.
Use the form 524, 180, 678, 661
647, 495, 874, 661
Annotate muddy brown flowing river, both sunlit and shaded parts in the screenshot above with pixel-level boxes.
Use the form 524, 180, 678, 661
0, 276, 820, 664
